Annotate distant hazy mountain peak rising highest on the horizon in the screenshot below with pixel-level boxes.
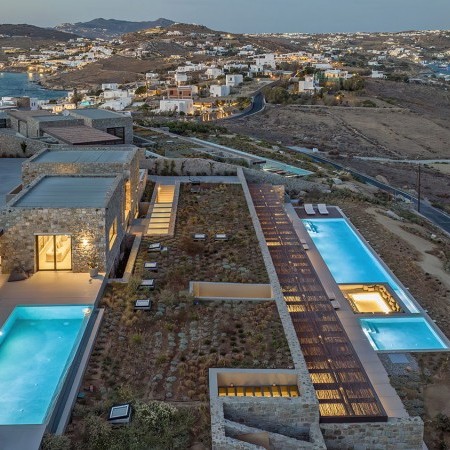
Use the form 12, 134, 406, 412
55, 18, 174, 39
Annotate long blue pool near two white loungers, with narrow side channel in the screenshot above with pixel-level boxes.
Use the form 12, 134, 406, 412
303, 219, 419, 313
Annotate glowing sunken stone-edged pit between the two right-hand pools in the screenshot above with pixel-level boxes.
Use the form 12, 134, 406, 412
339, 284, 402, 314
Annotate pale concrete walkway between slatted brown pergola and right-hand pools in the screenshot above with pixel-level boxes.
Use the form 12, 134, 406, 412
285, 204, 409, 417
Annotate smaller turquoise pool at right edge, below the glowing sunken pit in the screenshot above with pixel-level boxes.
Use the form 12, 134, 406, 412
359, 317, 448, 352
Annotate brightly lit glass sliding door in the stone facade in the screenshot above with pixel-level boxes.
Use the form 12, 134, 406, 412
36, 234, 72, 270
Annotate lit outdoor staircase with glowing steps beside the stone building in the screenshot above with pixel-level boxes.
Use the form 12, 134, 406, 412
147, 184, 175, 236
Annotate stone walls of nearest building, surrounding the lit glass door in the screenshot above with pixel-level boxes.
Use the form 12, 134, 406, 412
0, 178, 124, 273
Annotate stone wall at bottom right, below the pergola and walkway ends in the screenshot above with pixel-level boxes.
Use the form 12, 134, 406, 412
320, 417, 423, 450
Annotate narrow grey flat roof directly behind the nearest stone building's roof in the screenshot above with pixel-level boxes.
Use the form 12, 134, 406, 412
33, 149, 131, 163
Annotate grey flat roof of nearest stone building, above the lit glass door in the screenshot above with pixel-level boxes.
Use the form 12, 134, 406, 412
12, 176, 116, 208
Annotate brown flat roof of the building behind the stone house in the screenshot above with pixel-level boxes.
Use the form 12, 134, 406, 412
42, 125, 122, 145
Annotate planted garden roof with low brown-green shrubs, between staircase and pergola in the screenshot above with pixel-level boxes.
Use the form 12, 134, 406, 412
59, 185, 293, 450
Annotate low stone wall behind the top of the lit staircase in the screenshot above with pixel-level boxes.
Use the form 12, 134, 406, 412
141, 158, 236, 176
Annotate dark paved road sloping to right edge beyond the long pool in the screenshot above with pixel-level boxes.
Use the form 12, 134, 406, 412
290, 147, 450, 234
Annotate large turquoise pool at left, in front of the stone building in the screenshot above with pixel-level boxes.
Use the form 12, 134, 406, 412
0, 305, 91, 425
